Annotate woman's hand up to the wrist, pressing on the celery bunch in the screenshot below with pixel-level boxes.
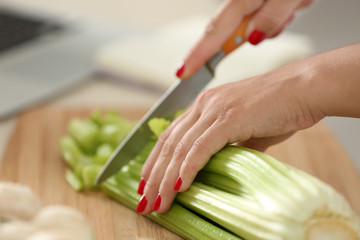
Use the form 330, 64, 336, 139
137, 56, 323, 214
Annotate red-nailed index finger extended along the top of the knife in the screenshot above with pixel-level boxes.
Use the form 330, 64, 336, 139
176, 0, 263, 79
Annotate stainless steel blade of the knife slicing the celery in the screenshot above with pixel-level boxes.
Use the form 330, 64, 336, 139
96, 65, 214, 183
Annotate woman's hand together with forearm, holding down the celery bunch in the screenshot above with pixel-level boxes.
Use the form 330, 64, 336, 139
137, 44, 360, 214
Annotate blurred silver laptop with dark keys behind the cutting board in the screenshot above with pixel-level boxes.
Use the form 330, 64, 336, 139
0, 3, 129, 120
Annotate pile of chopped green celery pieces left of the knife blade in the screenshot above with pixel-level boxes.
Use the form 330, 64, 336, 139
60, 110, 134, 191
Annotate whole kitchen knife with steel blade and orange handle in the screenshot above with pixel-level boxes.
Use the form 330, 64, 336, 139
96, 16, 251, 184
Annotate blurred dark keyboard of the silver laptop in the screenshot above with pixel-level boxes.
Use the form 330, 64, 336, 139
0, 10, 61, 54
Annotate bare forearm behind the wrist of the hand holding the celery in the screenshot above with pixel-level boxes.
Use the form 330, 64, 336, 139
303, 44, 360, 117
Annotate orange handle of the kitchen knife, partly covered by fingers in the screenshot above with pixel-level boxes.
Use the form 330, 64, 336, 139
221, 14, 253, 55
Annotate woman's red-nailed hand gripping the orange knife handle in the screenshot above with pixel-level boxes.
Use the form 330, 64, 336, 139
176, 0, 312, 79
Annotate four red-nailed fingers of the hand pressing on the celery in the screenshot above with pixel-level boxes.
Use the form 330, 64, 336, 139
137, 102, 233, 214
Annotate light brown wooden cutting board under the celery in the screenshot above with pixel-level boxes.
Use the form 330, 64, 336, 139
0, 107, 360, 240
